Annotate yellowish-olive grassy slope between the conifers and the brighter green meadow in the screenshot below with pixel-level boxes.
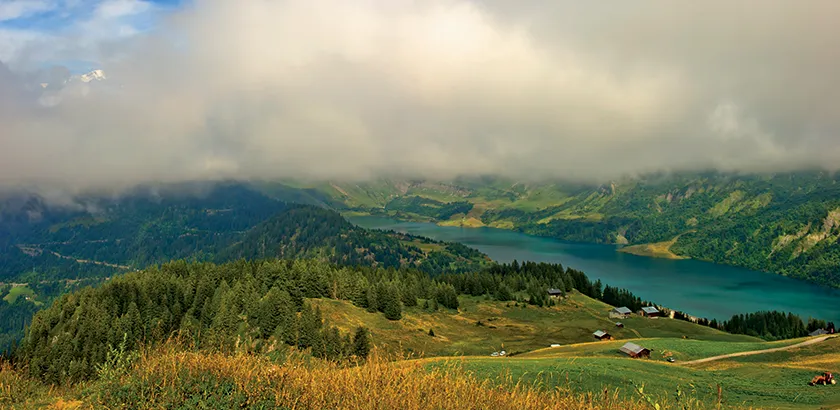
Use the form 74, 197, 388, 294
313, 292, 760, 356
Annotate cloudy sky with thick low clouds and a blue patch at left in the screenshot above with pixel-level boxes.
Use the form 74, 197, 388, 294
0, 0, 840, 189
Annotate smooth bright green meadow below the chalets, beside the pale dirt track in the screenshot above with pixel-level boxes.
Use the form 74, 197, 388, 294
428, 338, 840, 409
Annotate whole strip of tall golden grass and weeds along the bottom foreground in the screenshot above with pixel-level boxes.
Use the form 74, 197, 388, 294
0, 345, 748, 410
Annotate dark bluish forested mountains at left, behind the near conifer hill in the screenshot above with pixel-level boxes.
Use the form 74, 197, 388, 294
0, 183, 485, 281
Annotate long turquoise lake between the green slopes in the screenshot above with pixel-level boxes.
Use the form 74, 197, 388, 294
348, 216, 840, 322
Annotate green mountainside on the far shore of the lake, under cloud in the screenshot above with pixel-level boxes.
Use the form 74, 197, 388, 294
300, 171, 840, 287
